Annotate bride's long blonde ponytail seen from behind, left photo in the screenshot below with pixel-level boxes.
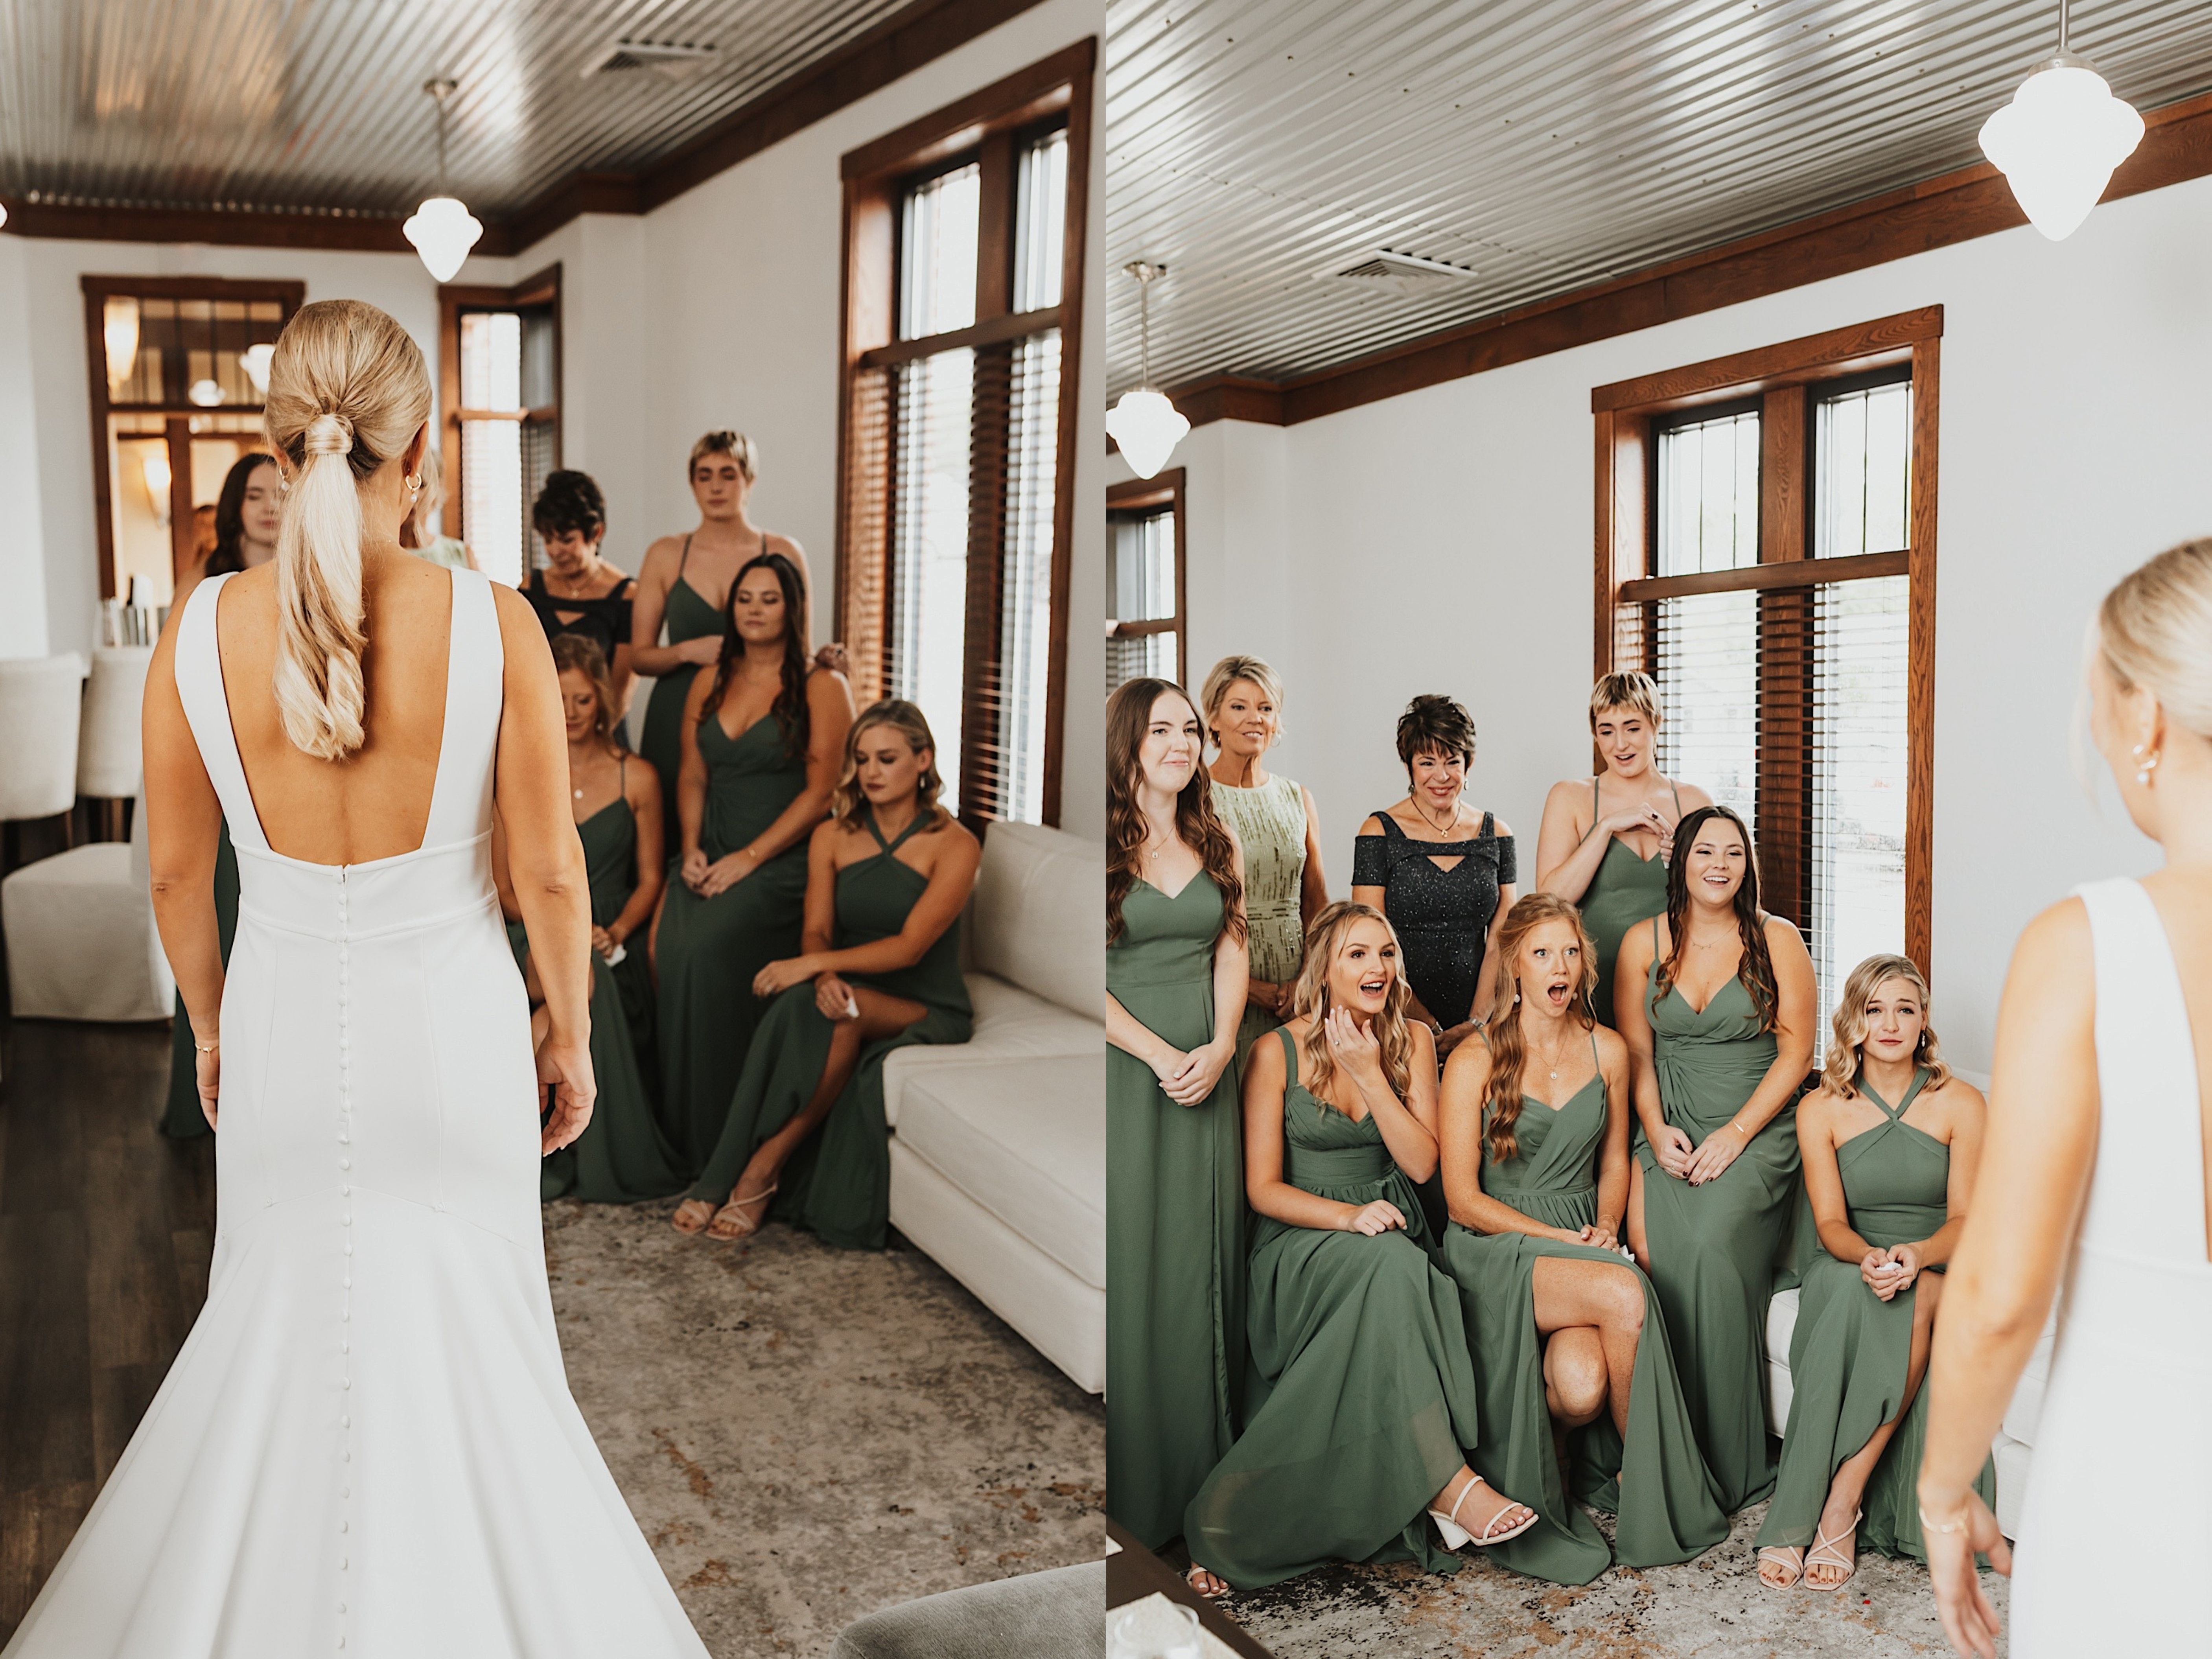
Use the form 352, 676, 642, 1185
261, 298, 429, 761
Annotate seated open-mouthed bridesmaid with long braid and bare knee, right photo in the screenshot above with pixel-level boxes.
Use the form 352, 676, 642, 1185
1440, 894, 1728, 1584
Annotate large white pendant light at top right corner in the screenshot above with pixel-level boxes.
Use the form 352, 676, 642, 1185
1982, 0, 2144, 241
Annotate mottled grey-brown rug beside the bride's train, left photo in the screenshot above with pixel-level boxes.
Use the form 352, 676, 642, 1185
544, 1201, 1106, 1659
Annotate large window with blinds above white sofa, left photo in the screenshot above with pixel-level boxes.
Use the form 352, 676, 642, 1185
838, 57, 1089, 823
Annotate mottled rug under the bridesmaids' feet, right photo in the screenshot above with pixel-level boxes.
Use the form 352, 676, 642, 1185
1228, 1504, 2006, 1659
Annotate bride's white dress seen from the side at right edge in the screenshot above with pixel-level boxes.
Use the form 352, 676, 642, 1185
2009, 878, 2212, 1659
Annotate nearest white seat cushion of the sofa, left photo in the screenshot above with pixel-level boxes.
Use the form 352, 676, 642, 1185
898, 1057, 1106, 1290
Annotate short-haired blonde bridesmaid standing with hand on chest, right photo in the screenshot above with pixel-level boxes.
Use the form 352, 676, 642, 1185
1535, 675, 1712, 1026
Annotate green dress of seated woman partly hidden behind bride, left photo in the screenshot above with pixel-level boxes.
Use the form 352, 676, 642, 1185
519, 757, 683, 1203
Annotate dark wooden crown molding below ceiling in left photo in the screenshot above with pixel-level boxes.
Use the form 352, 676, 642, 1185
4, 0, 1037, 259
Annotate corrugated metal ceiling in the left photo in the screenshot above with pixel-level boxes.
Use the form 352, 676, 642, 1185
0, 0, 905, 215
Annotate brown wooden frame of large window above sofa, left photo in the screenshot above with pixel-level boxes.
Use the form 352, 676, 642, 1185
836, 38, 1097, 825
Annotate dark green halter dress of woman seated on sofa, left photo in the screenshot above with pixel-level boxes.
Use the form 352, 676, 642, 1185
690, 814, 973, 1250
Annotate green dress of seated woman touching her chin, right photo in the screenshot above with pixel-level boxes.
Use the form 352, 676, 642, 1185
1186, 1031, 1477, 1591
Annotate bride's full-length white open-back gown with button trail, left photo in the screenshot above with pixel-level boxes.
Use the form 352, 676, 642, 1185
4, 571, 705, 1659
